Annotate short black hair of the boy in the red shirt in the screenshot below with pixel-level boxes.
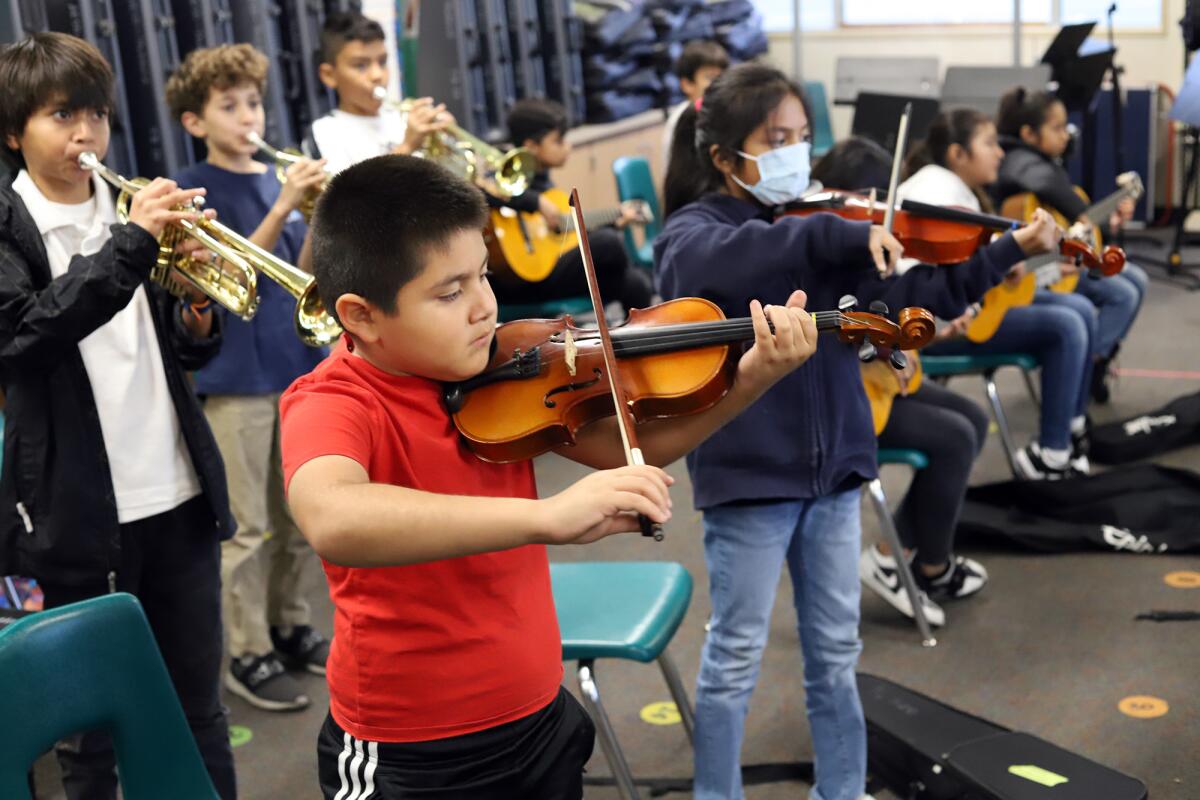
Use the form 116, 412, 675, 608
312, 156, 487, 314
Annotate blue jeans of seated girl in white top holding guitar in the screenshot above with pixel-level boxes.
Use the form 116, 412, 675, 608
925, 291, 1096, 450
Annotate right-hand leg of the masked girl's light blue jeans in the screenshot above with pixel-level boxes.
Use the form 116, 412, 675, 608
787, 489, 866, 800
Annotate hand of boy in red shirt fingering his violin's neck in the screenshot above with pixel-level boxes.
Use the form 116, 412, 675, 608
737, 289, 817, 393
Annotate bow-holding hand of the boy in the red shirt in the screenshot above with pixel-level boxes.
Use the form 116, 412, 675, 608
535, 465, 674, 545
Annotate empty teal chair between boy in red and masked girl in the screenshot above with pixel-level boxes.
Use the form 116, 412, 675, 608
550, 561, 695, 799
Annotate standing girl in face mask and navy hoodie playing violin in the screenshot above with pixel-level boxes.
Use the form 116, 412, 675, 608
654, 64, 1054, 800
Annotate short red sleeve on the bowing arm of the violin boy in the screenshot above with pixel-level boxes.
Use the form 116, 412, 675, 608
280, 385, 372, 492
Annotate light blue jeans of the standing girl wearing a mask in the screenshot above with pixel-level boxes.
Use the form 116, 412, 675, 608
695, 489, 866, 800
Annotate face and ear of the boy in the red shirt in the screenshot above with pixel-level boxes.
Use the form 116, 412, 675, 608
336, 230, 497, 381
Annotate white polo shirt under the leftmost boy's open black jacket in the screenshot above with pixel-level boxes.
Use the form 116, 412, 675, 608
12, 169, 200, 524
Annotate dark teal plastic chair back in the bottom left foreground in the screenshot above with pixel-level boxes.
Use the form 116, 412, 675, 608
0, 594, 217, 800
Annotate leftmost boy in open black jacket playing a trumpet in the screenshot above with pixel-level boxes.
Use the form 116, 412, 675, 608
0, 34, 236, 800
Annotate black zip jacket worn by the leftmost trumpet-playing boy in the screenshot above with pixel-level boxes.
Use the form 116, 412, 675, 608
0, 174, 234, 585
